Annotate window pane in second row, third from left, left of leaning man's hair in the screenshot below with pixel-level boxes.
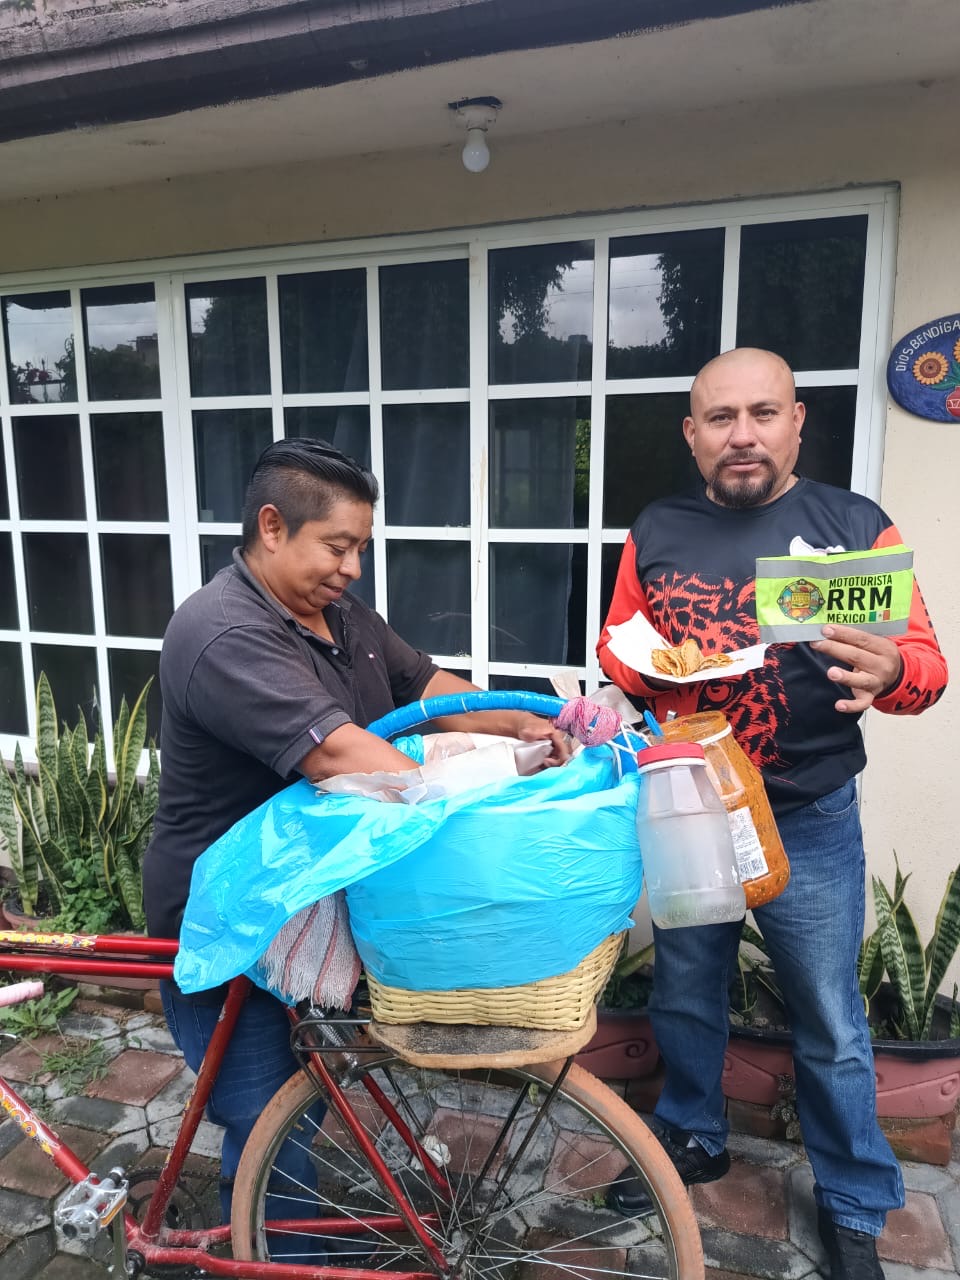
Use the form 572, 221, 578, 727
193, 408, 273, 521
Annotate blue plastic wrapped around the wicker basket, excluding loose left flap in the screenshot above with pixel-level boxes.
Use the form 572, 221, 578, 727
347, 748, 643, 991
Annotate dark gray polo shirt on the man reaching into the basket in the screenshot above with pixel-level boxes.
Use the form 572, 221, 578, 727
143, 550, 436, 937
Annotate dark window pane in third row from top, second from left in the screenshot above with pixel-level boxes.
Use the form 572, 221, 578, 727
100, 534, 173, 637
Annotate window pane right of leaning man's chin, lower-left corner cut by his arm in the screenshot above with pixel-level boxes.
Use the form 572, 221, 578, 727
387, 541, 470, 654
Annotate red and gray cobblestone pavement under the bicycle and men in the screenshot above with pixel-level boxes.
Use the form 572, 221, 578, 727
0, 992, 960, 1280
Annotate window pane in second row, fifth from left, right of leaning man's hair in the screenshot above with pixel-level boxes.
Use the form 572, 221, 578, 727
383, 404, 470, 526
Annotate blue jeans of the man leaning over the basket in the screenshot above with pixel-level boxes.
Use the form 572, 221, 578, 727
160, 982, 323, 1233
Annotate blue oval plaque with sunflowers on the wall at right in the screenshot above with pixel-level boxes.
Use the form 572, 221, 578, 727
887, 315, 960, 422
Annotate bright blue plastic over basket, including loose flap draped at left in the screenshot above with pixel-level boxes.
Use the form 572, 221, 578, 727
175, 748, 641, 992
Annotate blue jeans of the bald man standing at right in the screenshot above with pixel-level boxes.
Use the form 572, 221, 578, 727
650, 780, 904, 1235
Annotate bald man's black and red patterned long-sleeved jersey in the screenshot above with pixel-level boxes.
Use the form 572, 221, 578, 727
596, 477, 947, 813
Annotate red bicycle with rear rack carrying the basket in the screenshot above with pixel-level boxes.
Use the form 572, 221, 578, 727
0, 695, 704, 1280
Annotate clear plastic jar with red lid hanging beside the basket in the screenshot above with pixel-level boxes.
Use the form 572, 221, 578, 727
636, 742, 746, 929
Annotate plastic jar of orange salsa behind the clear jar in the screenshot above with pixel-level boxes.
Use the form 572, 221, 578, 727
660, 712, 790, 908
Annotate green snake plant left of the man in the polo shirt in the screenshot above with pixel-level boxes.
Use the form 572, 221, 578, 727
0, 673, 159, 933
